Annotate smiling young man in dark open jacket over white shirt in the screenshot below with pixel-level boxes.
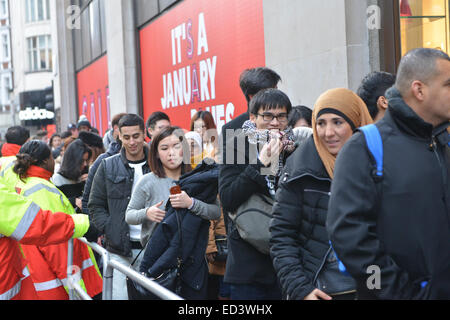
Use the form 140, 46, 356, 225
88, 114, 150, 300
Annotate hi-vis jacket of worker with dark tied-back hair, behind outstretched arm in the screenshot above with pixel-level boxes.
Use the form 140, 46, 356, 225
16, 170, 103, 300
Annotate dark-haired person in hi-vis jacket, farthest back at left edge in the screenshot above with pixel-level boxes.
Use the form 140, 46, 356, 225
0, 126, 30, 190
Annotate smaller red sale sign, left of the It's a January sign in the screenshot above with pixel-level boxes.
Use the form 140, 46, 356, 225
77, 55, 111, 136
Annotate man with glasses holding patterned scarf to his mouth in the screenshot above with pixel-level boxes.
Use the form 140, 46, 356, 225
219, 89, 293, 300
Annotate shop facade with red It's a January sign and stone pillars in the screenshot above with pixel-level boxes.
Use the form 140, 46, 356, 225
51, 0, 449, 132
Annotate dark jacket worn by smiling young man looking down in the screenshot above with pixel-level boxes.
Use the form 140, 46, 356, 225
88, 148, 150, 257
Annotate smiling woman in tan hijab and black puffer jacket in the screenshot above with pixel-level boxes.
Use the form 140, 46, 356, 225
270, 88, 372, 300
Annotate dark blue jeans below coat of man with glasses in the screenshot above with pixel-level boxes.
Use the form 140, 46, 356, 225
230, 283, 281, 300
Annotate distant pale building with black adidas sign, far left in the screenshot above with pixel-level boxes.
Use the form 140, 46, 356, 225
9, 0, 57, 134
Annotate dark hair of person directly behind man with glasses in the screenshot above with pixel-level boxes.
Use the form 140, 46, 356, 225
239, 67, 281, 102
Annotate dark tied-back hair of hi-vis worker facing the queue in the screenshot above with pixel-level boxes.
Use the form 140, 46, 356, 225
13, 140, 51, 181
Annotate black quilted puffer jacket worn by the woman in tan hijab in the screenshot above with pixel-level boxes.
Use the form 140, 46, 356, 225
270, 136, 355, 300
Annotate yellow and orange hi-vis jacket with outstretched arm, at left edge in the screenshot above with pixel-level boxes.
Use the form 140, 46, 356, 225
0, 183, 89, 300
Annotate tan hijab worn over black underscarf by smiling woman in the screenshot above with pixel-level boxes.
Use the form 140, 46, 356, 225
312, 88, 373, 179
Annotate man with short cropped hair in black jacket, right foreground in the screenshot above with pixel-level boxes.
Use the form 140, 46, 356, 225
327, 48, 450, 299
